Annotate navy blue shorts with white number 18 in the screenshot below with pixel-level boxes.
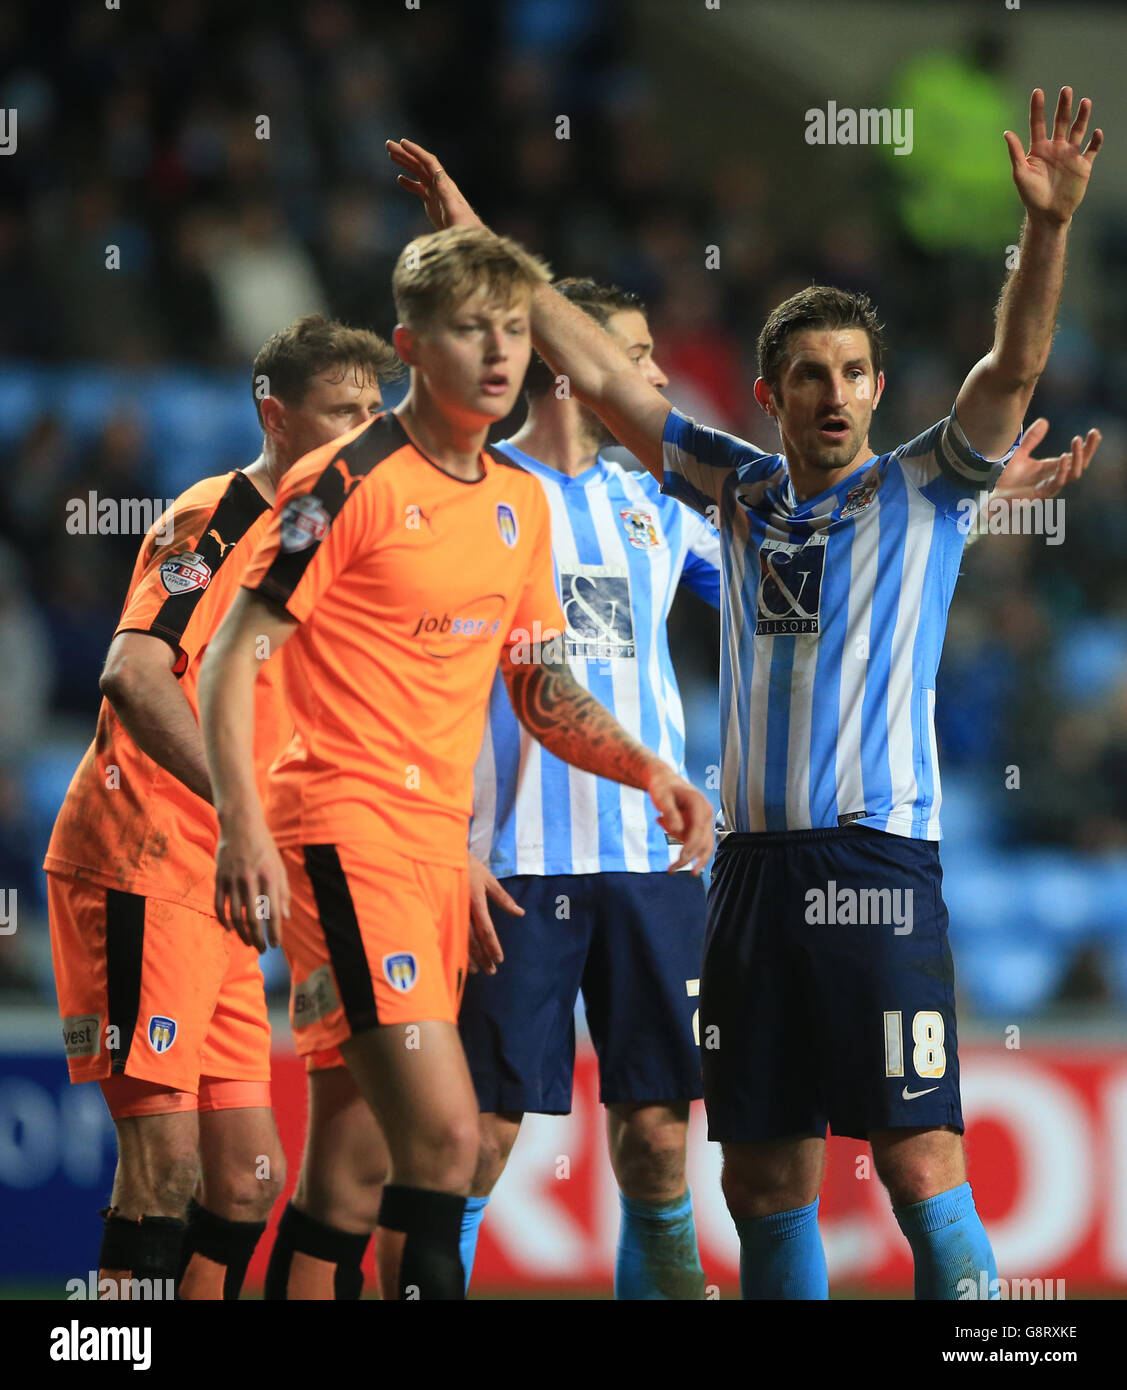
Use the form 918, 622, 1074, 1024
700, 826, 963, 1144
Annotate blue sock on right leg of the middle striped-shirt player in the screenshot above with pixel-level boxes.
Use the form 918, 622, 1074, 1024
614, 1191, 705, 1298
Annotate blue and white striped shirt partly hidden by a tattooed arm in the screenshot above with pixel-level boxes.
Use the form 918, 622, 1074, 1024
470, 441, 720, 877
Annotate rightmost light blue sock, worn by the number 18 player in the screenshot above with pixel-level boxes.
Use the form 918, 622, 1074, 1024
892, 1183, 1001, 1298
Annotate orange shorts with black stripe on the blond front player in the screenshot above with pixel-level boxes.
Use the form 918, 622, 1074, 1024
281, 845, 470, 1069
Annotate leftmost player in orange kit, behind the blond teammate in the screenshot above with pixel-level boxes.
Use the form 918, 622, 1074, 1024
44, 316, 402, 1298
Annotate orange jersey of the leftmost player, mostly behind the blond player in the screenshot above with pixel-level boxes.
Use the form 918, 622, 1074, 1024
43, 473, 292, 913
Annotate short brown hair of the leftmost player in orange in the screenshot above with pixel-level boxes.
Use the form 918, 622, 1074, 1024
250, 314, 403, 424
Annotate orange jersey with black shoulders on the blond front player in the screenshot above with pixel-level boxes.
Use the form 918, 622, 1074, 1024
243, 414, 564, 866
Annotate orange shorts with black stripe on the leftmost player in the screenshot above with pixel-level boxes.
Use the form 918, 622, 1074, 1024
47, 873, 270, 1095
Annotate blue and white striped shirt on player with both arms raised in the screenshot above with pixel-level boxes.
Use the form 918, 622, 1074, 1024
663, 410, 1016, 840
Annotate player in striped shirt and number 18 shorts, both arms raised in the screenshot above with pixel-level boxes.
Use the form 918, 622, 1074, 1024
390, 88, 1103, 1298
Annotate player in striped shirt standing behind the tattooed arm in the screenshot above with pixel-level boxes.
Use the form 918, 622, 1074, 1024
459, 279, 720, 1298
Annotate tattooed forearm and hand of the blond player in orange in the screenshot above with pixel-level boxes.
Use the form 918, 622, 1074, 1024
500, 641, 713, 874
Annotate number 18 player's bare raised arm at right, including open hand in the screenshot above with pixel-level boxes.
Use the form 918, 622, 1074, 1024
955, 88, 1103, 459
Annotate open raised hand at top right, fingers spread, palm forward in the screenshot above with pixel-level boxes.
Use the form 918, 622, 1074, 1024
1005, 88, 1103, 225
